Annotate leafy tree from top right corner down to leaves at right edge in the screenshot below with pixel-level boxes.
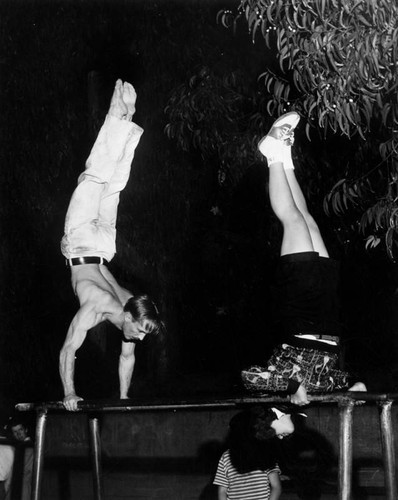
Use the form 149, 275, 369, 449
219, 0, 398, 260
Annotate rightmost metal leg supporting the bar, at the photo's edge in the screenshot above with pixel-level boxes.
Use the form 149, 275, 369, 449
380, 401, 398, 500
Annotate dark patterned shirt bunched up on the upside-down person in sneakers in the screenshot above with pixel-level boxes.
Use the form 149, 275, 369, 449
241, 344, 349, 394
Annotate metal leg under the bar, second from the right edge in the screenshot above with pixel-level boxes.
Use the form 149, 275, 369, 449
338, 401, 354, 500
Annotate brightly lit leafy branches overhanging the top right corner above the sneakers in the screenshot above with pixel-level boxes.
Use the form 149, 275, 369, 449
221, 0, 398, 138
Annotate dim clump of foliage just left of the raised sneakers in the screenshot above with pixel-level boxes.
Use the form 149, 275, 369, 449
165, 66, 267, 187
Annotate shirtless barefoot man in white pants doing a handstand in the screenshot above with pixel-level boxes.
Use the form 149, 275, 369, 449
59, 80, 162, 411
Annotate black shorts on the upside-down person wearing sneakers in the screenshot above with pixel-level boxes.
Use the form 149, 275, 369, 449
275, 252, 341, 337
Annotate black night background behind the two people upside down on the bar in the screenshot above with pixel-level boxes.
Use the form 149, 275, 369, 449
0, 0, 398, 420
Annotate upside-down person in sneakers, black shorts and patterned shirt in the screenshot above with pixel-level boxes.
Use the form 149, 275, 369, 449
242, 112, 366, 405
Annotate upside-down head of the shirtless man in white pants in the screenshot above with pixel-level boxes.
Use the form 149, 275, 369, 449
122, 294, 163, 342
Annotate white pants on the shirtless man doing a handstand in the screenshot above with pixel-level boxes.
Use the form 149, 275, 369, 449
61, 115, 143, 261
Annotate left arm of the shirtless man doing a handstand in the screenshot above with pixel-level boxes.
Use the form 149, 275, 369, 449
59, 304, 99, 411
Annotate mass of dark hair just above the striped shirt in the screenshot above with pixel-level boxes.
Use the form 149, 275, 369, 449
229, 407, 280, 473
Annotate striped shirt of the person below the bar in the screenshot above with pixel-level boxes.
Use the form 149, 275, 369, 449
213, 450, 280, 500
